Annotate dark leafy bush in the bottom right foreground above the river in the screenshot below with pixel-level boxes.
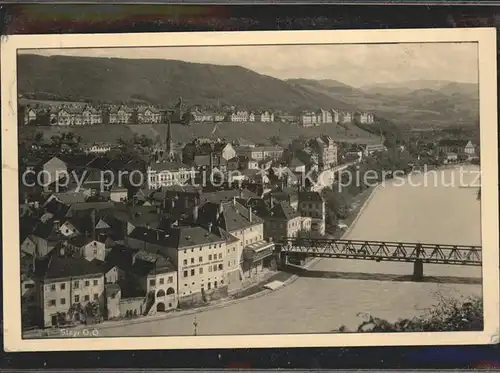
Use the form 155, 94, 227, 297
337, 297, 484, 333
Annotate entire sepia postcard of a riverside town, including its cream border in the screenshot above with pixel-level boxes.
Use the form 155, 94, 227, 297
2, 28, 500, 351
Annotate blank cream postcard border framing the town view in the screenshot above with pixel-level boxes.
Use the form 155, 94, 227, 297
1, 28, 500, 352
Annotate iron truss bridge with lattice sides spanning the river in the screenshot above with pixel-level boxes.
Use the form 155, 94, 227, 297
278, 238, 482, 266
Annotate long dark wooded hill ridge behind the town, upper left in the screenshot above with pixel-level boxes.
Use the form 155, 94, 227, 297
18, 55, 352, 111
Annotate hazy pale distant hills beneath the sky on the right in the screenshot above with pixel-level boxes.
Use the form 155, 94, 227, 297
294, 79, 479, 128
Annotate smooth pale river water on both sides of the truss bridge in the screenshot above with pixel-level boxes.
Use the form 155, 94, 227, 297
97, 166, 481, 336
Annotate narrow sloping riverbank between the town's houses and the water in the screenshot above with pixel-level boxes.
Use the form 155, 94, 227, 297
23, 180, 379, 338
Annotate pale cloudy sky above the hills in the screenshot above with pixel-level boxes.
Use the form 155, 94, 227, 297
24, 43, 478, 87
